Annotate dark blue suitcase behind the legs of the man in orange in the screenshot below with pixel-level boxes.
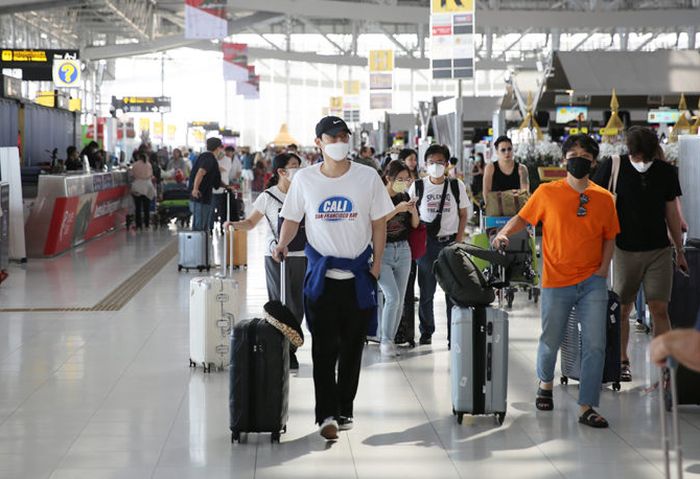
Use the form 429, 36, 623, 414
560, 291, 621, 391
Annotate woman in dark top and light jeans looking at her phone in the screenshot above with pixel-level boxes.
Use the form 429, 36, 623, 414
378, 160, 420, 356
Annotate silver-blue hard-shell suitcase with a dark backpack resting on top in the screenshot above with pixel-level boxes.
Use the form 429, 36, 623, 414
450, 306, 508, 424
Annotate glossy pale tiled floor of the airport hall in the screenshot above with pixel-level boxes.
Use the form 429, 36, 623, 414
0, 223, 700, 479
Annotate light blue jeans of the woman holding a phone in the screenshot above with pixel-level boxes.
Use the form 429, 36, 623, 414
379, 241, 411, 342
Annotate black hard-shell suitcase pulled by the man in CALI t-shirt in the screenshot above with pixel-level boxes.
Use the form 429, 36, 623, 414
229, 262, 290, 442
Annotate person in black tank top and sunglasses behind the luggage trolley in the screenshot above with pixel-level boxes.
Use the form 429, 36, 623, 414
483, 136, 530, 200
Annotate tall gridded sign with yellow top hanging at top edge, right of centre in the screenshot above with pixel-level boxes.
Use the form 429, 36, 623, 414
430, 0, 474, 80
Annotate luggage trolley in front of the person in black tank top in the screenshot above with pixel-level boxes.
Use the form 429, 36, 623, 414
471, 217, 540, 308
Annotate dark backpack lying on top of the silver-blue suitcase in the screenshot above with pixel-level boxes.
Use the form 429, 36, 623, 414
433, 243, 496, 307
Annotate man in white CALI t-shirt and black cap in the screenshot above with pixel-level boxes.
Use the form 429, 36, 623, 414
275, 116, 394, 440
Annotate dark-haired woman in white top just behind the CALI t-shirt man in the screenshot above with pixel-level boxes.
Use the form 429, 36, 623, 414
231, 153, 306, 369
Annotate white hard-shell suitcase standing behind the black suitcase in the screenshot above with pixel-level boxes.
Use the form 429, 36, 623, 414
190, 230, 240, 373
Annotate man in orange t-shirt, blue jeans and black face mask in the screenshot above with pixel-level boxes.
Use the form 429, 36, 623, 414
493, 135, 620, 428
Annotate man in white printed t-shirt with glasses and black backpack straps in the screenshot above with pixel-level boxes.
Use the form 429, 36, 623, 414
408, 145, 472, 348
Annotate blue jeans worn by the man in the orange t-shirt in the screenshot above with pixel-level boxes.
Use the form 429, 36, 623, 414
537, 275, 608, 406
